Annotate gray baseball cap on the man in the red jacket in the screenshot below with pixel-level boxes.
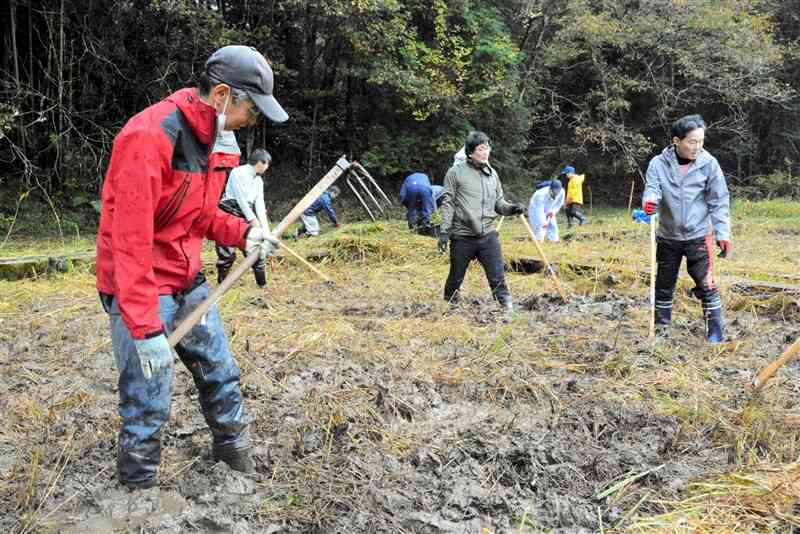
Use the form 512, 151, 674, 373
206, 45, 289, 122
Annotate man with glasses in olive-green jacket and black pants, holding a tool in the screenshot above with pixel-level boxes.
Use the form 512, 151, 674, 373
438, 132, 524, 312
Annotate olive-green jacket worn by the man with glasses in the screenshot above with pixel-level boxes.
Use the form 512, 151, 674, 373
441, 161, 513, 237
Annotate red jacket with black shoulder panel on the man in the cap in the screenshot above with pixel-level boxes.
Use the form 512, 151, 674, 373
97, 89, 249, 339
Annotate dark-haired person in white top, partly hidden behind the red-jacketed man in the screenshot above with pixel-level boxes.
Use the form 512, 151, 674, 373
215, 148, 272, 287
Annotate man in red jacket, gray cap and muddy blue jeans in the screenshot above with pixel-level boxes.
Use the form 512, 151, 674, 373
97, 46, 288, 488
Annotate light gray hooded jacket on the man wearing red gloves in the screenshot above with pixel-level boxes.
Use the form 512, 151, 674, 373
642, 146, 731, 241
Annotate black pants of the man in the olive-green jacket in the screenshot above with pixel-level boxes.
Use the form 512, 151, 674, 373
444, 232, 511, 304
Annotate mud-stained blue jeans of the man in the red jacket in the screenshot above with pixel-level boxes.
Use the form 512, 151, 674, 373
101, 280, 250, 485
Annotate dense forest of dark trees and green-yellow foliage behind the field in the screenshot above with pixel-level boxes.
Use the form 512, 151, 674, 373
0, 0, 800, 218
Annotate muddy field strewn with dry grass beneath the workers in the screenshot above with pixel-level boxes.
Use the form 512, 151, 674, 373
0, 211, 800, 534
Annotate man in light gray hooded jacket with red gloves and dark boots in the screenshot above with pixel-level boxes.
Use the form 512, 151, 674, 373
642, 115, 731, 343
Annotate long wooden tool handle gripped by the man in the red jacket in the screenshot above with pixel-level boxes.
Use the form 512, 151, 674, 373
167, 156, 350, 347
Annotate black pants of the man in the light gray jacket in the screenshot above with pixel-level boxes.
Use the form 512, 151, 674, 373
656, 236, 722, 313
